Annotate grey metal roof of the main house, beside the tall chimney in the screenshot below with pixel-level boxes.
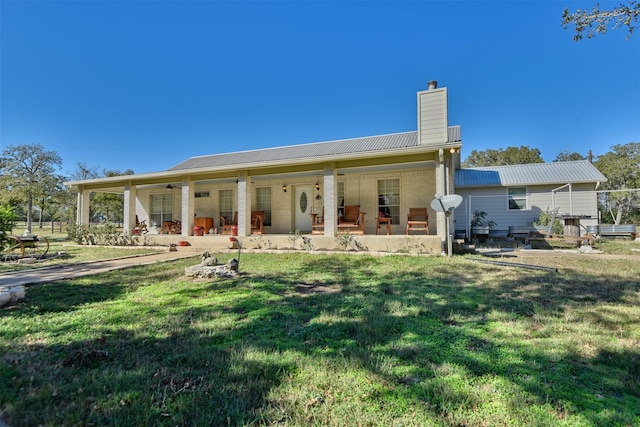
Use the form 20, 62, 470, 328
168, 126, 461, 171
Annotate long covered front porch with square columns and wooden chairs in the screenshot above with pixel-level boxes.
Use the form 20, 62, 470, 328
72, 150, 455, 249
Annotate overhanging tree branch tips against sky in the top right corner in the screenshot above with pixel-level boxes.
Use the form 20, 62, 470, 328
562, 0, 640, 41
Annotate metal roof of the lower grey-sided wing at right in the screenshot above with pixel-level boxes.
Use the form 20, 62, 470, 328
455, 160, 607, 188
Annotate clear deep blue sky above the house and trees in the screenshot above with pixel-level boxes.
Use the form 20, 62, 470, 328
0, 0, 640, 174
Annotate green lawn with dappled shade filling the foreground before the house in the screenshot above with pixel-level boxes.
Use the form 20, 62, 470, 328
0, 253, 640, 427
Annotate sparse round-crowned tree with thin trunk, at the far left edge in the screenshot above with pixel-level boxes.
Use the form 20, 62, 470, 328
0, 144, 62, 235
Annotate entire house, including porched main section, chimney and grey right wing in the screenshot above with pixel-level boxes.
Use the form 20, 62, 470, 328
66, 81, 605, 253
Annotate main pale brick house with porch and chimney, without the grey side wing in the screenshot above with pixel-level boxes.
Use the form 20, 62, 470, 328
66, 81, 462, 252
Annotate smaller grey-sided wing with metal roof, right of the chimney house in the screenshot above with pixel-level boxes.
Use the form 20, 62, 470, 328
454, 160, 607, 236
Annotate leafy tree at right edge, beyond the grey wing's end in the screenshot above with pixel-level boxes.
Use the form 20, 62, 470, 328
594, 142, 640, 224
